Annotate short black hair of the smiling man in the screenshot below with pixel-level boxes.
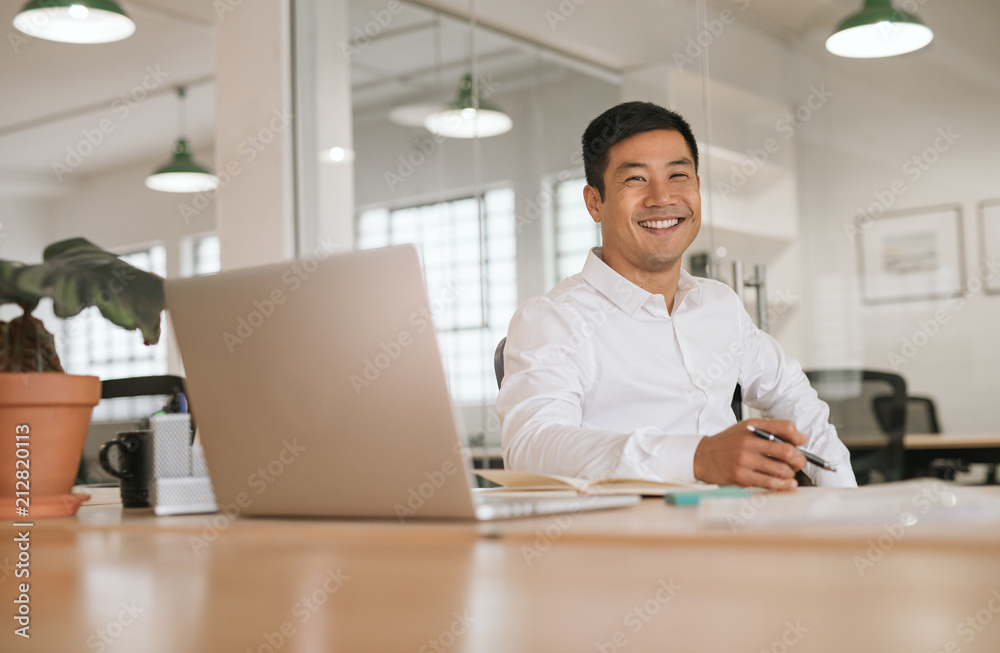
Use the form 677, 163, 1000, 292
582, 102, 698, 202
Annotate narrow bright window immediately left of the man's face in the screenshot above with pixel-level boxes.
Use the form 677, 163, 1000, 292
553, 177, 601, 281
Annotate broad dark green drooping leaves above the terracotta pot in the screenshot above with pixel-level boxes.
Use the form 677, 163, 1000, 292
0, 238, 165, 345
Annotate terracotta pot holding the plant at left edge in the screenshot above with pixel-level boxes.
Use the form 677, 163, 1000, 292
0, 372, 101, 520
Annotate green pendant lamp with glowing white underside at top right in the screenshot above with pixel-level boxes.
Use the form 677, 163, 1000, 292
826, 0, 934, 59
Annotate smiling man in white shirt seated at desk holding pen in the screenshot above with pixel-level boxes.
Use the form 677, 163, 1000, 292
497, 102, 856, 490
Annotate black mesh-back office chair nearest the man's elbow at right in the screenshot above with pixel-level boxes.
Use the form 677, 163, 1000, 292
806, 369, 907, 485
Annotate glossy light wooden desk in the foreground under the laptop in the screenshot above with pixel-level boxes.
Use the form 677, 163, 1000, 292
0, 489, 1000, 653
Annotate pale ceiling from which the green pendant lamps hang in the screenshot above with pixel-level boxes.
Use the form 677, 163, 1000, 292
0, 0, 1000, 195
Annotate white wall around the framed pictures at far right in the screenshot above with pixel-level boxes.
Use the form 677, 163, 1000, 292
799, 59, 1000, 433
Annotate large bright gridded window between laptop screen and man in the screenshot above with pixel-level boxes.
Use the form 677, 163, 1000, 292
356, 188, 517, 403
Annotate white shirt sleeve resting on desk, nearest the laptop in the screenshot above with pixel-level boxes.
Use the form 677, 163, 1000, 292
497, 298, 702, 482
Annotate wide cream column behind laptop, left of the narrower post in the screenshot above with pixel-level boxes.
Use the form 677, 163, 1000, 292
215, 0, 295, 269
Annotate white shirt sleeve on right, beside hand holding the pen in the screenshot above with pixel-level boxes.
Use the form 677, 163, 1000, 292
737, 299, 858, 487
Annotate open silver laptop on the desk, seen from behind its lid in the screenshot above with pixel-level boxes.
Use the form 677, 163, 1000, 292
160, 245, 639, 521
